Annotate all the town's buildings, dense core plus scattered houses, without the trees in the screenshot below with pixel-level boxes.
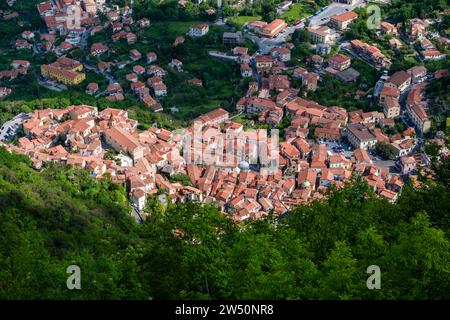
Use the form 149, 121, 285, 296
0, 0, 448, 221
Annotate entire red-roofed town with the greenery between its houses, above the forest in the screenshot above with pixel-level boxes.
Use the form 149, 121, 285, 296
0, 0, 450, 221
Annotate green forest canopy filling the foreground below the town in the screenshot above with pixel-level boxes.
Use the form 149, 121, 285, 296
0, 148, 450, 300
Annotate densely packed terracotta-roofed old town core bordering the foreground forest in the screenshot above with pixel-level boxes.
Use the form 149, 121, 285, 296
1, 102, 426, 221
